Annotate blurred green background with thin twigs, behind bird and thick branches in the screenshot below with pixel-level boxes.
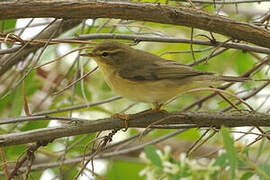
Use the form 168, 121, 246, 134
0, 0, 270, 180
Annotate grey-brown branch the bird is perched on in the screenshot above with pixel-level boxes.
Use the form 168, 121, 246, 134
0, 112, 270, 147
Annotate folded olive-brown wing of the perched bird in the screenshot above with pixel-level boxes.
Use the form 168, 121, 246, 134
119, 60, 213, 81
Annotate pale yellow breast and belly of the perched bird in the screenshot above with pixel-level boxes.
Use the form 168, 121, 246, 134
99, 64, 200, 104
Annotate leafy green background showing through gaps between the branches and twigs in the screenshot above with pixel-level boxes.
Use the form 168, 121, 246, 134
0, 1, 270, 180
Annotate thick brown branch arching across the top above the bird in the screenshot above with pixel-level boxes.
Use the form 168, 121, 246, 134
0, 0, 270, 48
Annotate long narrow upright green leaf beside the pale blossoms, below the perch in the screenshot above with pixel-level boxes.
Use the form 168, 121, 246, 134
221, 127, 238, 179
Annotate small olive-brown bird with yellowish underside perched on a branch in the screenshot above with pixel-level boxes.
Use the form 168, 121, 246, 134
80, 41, 247, 111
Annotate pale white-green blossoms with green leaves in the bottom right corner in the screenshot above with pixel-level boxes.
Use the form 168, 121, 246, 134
140, 128, 270, 180
